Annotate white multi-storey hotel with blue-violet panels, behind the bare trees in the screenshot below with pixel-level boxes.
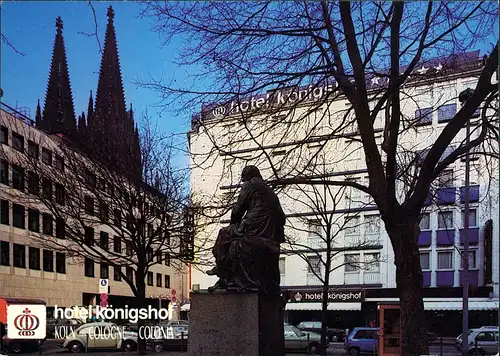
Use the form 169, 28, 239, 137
189, 52, 500, 336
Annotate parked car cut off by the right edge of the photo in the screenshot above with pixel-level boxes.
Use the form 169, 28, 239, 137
455, 326, 499, 356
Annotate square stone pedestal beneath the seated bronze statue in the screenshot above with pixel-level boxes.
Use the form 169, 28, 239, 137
187, 292, 284, 356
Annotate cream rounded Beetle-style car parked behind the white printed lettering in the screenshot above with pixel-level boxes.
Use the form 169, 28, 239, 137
59, 322, 138, 353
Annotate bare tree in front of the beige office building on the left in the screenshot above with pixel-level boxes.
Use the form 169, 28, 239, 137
1, 112, 194, 351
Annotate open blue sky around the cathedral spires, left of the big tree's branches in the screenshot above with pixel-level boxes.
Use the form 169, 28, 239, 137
0, 1, 190, 137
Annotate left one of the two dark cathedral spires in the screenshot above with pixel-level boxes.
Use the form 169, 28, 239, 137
41, 17, 76, 136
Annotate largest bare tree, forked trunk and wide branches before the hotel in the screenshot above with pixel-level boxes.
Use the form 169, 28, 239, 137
139, 1, 498, 355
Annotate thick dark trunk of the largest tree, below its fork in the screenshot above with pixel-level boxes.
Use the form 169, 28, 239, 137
386, 221, 428, 356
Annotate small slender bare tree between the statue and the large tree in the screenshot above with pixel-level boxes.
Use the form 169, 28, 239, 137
283, 176, 382, 355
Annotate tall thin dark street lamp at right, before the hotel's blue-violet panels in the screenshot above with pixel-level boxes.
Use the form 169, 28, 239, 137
458, 88, 474, 356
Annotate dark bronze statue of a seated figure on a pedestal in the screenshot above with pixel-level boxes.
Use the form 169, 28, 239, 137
206, 166, 285, 296
